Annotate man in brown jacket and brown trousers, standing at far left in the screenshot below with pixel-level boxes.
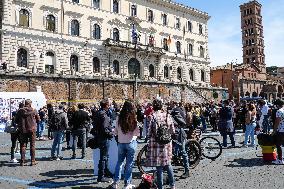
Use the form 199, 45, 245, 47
16, 99, 40, 166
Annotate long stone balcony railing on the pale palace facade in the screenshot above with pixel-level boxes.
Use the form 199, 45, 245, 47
104, 38, 165, 55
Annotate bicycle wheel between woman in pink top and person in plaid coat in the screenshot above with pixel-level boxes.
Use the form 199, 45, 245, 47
137, 145, 156, 174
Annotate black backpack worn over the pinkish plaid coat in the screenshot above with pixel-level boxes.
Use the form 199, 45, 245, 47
153, 114, 172, 145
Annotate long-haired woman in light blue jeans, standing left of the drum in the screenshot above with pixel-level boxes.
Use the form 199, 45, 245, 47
244, 104, 256, 147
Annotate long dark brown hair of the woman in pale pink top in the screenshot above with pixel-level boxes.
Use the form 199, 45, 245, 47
118, 100, 137, 134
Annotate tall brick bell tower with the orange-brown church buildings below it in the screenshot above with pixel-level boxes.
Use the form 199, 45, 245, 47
211, 0, 267, 99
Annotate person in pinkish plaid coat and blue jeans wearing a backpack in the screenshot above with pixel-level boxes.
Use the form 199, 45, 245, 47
146, 100, 175, 189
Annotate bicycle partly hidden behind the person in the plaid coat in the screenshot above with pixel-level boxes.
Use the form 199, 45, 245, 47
137, 139, 201, 174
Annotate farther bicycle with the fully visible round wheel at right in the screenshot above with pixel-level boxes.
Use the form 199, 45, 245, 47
185, 129, 222, 161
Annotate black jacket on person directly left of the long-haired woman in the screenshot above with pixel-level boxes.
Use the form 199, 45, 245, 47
91, 110, 113, 140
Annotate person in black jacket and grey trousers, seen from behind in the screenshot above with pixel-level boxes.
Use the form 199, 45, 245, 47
71, 104, 90, 159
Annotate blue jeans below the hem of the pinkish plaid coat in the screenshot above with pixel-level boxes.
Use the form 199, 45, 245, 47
156, 165, 175, 189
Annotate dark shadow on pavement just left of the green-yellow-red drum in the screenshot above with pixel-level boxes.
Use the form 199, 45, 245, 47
224, 158, 270, 167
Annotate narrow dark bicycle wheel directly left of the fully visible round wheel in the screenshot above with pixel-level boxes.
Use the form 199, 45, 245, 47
185, 139, 201, 169
